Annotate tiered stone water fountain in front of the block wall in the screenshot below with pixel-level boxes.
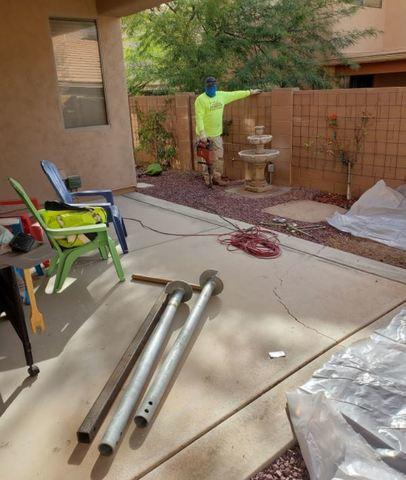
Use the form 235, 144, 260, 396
238, 127, 280, 193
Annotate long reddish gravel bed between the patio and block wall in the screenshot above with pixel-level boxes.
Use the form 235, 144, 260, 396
140, 171, 406, 268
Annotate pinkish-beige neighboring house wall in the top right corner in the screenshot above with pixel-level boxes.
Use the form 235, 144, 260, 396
341, 0, 406, 56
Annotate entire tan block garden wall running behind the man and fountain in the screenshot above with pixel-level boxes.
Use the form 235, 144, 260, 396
130, 87, 406, 196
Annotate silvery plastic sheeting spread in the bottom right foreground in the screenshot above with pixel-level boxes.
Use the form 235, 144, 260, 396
287, 310, 406, 480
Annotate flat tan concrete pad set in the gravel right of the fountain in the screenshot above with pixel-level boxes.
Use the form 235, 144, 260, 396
262, 200, 347, 223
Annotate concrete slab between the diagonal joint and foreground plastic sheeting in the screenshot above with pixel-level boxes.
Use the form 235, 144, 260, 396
144, 304, 406, 480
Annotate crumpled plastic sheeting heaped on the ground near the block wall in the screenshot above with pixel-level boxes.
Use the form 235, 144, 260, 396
327, 180, 406, 250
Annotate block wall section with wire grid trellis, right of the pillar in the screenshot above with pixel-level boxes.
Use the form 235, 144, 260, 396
292, 87, 406, 196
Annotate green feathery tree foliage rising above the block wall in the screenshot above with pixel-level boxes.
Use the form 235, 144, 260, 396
123, 0, 375, 93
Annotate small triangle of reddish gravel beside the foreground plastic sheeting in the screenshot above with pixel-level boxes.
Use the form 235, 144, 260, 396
250, 446, 310, 480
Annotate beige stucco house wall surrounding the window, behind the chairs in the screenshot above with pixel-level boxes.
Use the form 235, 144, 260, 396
0, 0, 136, 200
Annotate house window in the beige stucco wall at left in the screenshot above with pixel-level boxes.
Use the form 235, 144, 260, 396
50, 18, 108, 128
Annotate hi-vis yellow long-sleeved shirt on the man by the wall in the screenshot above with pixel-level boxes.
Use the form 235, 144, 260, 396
195, 90, 250, 137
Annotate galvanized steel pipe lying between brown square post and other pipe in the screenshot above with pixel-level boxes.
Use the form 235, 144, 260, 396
99, 282, 193, 456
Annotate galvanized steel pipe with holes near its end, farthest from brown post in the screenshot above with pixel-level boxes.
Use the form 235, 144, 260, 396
134, 270, 223, 427
